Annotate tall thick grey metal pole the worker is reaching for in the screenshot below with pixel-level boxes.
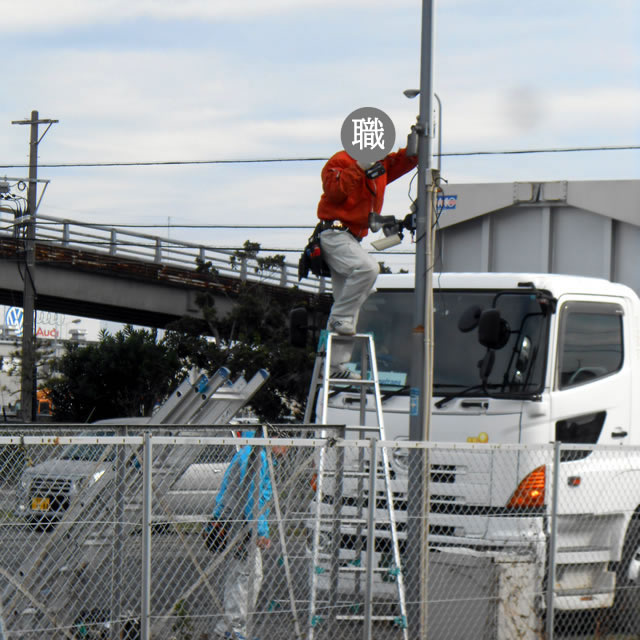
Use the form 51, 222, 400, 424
405, 0, 434, 638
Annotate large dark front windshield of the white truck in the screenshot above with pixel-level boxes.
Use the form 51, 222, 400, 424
352, 290, 549, 397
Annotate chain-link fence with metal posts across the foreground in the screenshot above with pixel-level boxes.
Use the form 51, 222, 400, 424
0, 425, 640, 640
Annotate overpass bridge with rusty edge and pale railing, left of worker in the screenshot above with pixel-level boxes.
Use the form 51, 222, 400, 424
0, 210, 330, 328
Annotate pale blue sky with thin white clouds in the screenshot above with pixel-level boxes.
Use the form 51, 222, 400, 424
0, 0, 640, 270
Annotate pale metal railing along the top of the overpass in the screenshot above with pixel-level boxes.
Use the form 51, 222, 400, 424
0, 209, 330, 293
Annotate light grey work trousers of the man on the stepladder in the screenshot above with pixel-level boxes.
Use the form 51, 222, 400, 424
320, 229, 380, 363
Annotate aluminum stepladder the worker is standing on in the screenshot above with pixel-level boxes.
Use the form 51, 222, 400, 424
305, 331, 409, 640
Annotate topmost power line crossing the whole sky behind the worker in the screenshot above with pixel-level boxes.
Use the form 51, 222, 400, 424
0, 144, 640, 169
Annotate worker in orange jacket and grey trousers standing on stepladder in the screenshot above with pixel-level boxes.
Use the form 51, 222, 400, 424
318, 149, 418, 379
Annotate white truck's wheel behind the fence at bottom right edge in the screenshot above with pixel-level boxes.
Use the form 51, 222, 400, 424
612, 516, 640, 634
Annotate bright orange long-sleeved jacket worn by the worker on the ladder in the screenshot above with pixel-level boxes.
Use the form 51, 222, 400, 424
318, 149, 418, 238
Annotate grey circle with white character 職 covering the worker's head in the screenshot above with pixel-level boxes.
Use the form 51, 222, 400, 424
340, 107, 396, 164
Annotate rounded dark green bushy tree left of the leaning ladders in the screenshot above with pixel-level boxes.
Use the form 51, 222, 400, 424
44, 326, 182, 422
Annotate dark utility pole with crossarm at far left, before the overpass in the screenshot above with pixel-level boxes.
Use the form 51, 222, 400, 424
11, 111, 58, 422
